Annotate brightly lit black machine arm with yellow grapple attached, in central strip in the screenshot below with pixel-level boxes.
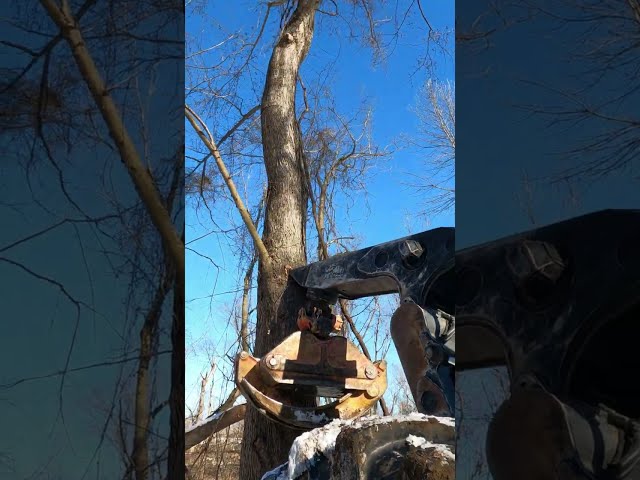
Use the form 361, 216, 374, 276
235, 228, 455, 430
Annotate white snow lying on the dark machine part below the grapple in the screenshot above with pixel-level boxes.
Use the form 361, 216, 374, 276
278, 413, 455, 480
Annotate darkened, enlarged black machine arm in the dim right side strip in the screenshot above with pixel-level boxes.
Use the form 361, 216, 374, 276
456, 210, 640, 480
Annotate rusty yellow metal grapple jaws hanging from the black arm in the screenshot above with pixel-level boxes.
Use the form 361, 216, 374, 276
235, 331, 387, 430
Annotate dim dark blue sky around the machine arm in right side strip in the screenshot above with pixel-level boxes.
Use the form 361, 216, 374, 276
456, 0, 640, 479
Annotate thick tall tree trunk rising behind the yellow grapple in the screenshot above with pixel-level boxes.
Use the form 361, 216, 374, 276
240, 0, 320, 480
